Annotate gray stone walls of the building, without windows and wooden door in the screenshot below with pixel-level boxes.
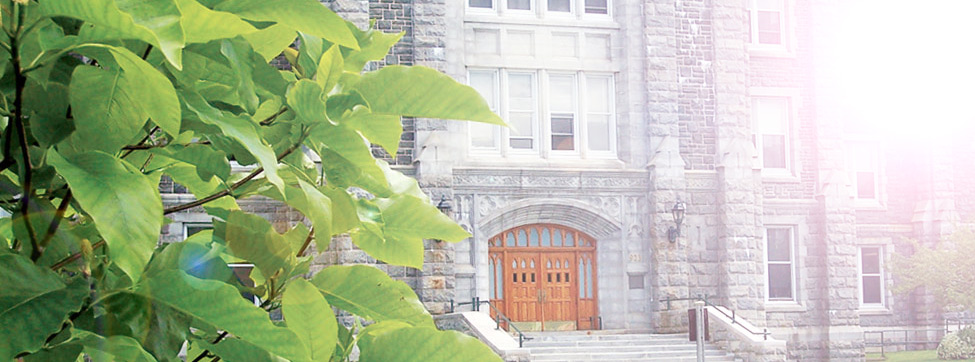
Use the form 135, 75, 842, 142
161, 0, 975, 360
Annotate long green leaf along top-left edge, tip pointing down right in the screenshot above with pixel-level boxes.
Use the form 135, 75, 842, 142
40, 0, 183, 69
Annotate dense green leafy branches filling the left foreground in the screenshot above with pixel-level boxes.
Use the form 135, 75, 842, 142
0, 0, 503, 361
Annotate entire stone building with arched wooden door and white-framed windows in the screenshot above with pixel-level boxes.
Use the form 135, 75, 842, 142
162, 0, 975, 359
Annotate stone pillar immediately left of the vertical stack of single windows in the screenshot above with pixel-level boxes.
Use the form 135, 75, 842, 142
713, 0, 765, 326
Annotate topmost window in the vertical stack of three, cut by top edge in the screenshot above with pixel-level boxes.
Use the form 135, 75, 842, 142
748, 0, 791, 53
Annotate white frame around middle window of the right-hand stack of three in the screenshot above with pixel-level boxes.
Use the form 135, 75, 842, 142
748, 87, 801, 182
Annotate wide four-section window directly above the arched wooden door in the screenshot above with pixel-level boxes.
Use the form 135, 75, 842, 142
468, 69, 616, 158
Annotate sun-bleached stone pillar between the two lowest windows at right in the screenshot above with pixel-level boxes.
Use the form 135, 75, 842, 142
810, 0, 864, 360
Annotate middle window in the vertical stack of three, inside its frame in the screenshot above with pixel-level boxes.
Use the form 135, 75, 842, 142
752, 97, 792, 174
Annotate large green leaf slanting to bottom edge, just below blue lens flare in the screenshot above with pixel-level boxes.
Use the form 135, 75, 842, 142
107, 270, 308, 361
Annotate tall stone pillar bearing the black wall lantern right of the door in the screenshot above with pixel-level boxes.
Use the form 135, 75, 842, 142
643, 0, 693, 333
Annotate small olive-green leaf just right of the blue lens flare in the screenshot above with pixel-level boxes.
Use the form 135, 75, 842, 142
224, 210, 295, 278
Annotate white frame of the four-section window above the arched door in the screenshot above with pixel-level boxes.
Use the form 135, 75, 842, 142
466, 67, 618, 160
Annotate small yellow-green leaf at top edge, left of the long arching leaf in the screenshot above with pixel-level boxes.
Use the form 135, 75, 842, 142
178, 0, 257, 44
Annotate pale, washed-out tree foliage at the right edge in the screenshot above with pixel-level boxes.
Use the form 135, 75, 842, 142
891, 228, 975, 310
